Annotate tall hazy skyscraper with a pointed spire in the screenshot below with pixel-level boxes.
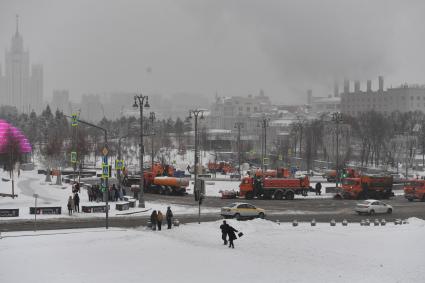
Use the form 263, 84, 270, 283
0, 17, 43, 113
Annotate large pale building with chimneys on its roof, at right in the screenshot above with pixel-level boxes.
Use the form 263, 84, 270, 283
341, 77, 425, 116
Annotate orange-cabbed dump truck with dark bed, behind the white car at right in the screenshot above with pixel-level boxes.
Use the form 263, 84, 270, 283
335, 175, 394, 199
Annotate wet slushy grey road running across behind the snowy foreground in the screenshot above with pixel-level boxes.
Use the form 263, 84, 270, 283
0, 194, 425, 232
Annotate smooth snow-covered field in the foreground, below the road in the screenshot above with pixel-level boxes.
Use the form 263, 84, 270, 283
0, 218, 425, 283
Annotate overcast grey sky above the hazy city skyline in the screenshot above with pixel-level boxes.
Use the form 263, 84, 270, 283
0, 0, 425, 103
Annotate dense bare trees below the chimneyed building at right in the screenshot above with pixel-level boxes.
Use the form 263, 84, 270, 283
275, 111, 425, 173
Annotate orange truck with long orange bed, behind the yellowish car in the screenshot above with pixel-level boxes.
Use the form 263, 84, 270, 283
239, 176, 310, 200
